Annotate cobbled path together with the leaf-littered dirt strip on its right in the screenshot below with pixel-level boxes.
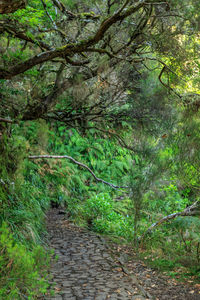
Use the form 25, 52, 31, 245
40, 209, 200, 300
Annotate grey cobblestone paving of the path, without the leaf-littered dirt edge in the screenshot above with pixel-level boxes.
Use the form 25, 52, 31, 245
43, 210, 151, 300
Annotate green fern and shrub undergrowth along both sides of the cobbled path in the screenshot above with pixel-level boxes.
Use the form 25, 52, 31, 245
0, 121, 200, 299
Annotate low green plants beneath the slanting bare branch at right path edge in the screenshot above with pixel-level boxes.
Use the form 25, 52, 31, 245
141, 217, 200, 281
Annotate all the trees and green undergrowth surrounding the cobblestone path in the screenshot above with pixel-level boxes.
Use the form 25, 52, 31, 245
0, 0, 200, 299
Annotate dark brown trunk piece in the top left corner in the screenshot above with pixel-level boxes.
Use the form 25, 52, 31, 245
0, 0, 27, 14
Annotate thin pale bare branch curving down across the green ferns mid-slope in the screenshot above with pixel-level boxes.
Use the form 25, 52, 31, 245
28, 155, 128, 189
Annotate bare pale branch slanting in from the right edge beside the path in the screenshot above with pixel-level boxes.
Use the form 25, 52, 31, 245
138, 201, 200, 242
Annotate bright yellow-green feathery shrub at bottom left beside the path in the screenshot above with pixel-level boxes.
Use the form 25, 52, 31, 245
0, 223, 49, 300
